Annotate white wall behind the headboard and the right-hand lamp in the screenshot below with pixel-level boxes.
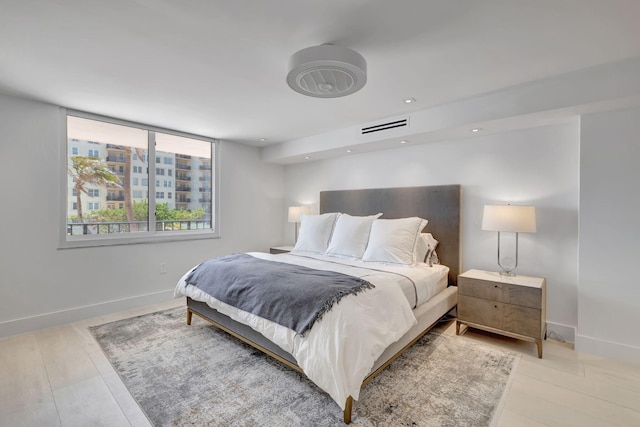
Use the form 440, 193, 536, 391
285, 120, 580, 341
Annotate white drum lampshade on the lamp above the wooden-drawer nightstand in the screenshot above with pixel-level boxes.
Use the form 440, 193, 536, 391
482, 205, 536, 233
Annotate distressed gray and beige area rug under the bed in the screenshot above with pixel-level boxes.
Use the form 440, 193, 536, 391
89, 308, 518, 427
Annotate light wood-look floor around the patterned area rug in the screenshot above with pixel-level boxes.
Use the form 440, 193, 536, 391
0, 299, 640, 427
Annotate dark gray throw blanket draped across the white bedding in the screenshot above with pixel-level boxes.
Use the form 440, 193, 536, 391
186, 254, 374, 335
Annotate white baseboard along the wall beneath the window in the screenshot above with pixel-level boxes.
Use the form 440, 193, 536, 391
0, 288, 173, 338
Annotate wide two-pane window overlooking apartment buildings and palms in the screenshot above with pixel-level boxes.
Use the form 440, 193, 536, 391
62, 112, 217, 247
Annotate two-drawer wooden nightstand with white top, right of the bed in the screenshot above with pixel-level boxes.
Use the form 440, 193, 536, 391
456, 270, 547, 359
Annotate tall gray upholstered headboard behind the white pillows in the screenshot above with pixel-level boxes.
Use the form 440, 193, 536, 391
320, 185, 460, 285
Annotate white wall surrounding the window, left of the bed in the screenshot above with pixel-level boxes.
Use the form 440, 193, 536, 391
0, 95, 285, 336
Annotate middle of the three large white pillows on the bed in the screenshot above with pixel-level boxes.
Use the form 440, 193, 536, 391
326, 213, 382, 258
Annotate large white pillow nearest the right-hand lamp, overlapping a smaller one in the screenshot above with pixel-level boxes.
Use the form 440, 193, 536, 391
362, 217, 427, 265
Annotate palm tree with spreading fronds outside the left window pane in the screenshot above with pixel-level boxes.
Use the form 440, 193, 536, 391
67, 156, 120, 223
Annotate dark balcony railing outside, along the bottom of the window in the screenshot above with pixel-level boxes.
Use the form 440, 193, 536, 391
67, 218, 211, 236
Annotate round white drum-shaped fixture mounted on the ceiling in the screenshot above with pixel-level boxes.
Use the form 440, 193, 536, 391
287, 44, 367, 98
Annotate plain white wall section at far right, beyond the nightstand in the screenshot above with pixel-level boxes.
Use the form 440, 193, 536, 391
576, 108, 640, 362
